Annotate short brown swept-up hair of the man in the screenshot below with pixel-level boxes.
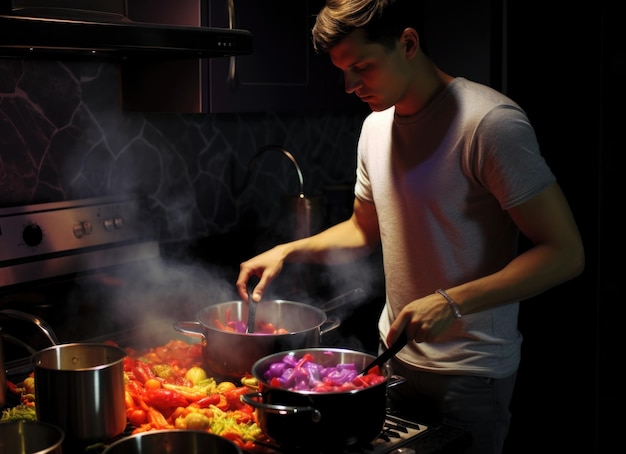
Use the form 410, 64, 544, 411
313, 0, 421, 52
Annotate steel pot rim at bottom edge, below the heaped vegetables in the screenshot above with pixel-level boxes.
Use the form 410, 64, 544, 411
102, 430, 243, 454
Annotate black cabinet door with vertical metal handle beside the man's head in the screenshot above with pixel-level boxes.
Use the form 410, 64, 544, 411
208, 0, 363, 112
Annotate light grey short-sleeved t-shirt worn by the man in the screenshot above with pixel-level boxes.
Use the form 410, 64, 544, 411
355, 78, 555, 378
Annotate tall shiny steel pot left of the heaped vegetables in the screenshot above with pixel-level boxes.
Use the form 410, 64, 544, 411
32, 343, 126, 441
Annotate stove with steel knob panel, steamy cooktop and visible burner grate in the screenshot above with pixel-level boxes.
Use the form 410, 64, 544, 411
0, 197, 467, 454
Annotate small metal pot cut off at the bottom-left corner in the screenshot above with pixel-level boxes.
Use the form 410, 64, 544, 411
0, 421, 65, 454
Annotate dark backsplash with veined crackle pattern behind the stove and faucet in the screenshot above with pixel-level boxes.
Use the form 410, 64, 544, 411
0, 59, 362, 245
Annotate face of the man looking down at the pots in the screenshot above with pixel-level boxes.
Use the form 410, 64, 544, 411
329, 30, 410, 111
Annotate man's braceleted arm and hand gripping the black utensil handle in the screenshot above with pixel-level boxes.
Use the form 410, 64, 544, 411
387, 183, 585, 343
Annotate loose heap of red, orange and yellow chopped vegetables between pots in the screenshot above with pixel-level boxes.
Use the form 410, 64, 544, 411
119, 341, 266, 450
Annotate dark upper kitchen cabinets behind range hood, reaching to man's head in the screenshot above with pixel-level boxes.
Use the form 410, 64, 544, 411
121, 0, 367, 113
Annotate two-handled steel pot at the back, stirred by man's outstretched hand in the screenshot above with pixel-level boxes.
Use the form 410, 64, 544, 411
174, 300, 341, 380
